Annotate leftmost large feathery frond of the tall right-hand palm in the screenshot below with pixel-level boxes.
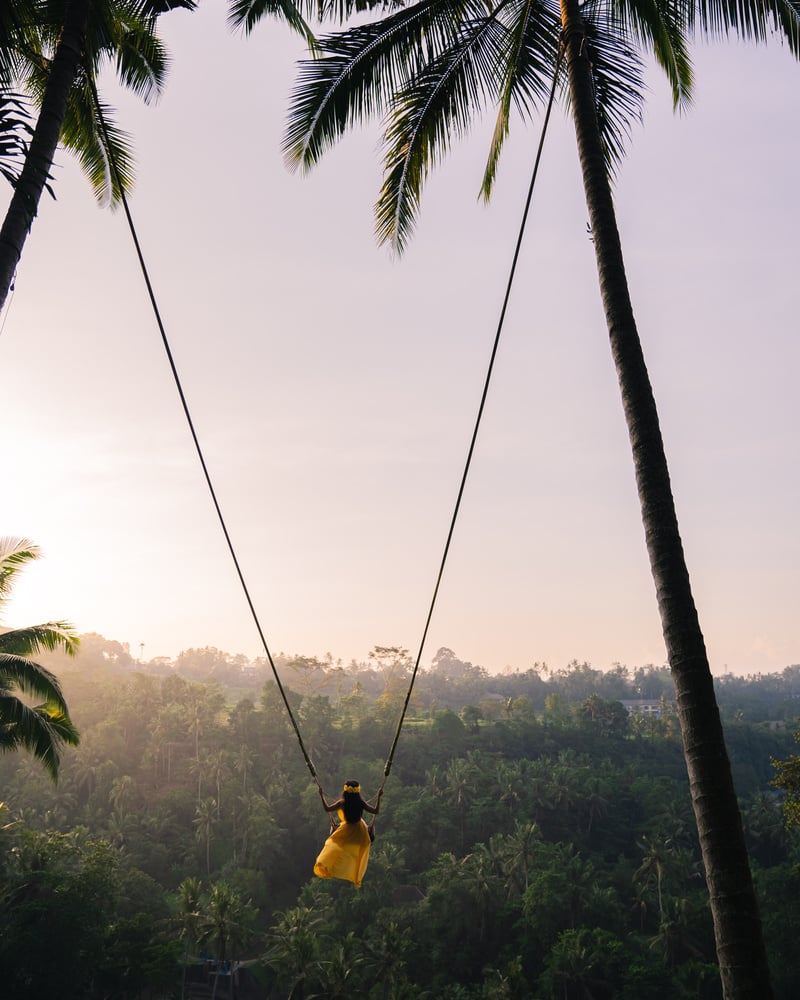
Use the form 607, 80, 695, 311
283, 0, 478, 168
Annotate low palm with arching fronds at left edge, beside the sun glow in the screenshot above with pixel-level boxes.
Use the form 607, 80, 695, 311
0, 538, 80, 781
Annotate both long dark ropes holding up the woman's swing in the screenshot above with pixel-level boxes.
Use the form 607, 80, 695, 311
92, 44, 564, 797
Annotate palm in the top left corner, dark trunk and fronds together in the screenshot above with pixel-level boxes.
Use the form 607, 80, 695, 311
0, 0, 195, 309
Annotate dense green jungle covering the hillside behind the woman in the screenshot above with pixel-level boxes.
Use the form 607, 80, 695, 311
0, 636, 800, 1000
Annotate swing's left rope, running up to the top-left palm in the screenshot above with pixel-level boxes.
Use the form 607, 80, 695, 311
87, 80, 320, 787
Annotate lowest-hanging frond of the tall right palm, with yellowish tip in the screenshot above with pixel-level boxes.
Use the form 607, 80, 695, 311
375, 17, 509, 252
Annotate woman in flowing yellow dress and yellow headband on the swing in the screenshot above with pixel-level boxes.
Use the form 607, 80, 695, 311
314, 780, 383, 889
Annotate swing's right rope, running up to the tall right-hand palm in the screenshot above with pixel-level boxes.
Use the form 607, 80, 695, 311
379, 45, 564, 794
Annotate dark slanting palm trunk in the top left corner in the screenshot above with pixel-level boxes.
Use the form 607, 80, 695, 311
0, 0, 91, 309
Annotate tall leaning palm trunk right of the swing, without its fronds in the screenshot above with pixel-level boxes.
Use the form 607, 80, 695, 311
561, 0, 772, 1000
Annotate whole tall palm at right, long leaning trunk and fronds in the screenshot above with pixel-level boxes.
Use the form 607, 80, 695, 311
276, 0, 800, 998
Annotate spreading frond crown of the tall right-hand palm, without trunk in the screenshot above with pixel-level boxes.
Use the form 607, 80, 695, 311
284, 0, 800, 251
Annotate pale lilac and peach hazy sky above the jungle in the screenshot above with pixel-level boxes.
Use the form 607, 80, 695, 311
0, 0, 800, 672
